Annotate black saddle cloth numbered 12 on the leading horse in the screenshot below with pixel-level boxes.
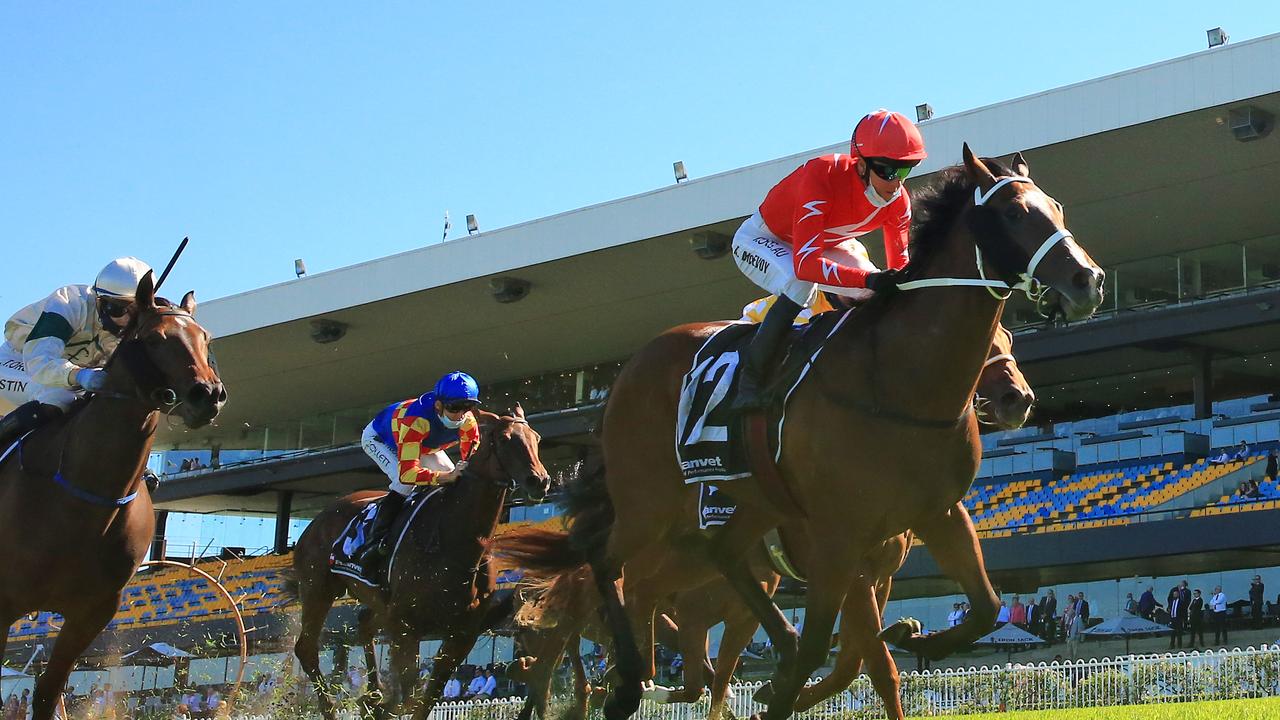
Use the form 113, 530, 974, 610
676, 310, 850, 486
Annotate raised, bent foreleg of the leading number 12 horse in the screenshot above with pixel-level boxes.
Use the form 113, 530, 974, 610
881, 502, 1000, 660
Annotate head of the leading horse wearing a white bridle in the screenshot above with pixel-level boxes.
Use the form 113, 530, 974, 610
964, 143, 1106, 320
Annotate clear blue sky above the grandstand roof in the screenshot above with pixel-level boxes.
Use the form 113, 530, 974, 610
0, 0, 1280, 316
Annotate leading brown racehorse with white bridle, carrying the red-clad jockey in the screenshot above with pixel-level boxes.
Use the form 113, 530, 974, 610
488, 146, 1105, 720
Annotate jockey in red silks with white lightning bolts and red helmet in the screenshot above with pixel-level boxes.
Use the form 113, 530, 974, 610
733, 110, 925, 411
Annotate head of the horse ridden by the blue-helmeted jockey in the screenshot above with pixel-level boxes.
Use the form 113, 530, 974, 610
467, 402, 552, 501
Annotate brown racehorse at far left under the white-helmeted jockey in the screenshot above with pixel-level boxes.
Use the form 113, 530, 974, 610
0, 273, 227, 720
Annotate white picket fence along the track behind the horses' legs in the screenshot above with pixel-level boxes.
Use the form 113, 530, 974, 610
230, 646, 1280, 720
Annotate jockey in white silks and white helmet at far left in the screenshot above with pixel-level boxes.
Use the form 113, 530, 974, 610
0, 258, 151, 446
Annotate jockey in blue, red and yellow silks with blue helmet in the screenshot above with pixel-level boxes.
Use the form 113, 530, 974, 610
360, 370, 480, 565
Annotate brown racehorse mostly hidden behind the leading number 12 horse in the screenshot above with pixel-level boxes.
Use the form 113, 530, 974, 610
504, 325, 1036, 720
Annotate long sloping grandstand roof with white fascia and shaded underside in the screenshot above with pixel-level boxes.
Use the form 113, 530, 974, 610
164, 35, 1280, 447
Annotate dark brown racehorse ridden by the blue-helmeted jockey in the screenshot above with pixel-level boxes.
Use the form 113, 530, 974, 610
285, 405, 550, 720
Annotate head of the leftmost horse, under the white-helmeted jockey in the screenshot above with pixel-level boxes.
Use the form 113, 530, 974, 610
102, 273, 227, 429
